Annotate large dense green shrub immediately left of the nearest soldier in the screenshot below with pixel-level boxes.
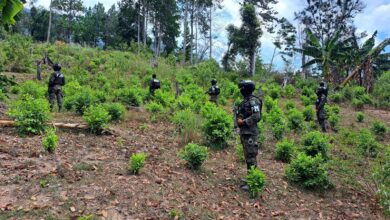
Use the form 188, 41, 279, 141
203, 108, 233, 149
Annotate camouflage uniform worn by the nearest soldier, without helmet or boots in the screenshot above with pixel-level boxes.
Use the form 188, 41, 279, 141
236, 87, 262, 170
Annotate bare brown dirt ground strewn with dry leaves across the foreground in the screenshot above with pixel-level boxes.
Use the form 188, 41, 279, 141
0, 104, 388, 219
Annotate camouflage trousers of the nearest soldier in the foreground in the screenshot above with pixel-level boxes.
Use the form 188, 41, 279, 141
240, 134, 259, 170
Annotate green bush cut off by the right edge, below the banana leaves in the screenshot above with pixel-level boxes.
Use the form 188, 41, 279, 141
373, 71, 390, 107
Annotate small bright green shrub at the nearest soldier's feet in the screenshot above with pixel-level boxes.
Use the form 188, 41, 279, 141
246, 166, 265, 198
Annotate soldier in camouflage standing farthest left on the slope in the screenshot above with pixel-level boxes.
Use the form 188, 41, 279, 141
48, 64, 65, 112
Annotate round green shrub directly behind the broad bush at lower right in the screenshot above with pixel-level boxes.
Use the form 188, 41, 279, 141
301, 131, 330, 160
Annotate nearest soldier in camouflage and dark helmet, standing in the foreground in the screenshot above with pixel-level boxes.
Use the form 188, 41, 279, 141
235, 80, 262, 189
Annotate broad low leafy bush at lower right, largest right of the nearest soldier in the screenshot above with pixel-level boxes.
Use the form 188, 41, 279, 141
285, 153, 331, 189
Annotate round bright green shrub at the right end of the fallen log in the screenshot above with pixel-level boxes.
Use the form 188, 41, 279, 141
83, 105, 111, 134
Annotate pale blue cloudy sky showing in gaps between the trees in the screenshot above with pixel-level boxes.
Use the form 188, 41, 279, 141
37, 0, 390, 70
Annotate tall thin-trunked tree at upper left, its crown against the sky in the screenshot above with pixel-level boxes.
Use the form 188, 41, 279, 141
52, 0, 84, 43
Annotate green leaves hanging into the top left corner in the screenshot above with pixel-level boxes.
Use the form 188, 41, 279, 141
0, 0, 23, 25
